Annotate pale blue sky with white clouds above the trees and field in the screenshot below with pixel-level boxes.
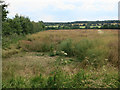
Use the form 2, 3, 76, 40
5, 0, 120, 22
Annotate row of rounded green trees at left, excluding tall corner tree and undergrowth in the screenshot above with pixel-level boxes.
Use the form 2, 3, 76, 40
3, 14, 45, 36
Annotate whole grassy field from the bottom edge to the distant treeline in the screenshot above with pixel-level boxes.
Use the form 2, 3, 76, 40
2, 29, 120, 88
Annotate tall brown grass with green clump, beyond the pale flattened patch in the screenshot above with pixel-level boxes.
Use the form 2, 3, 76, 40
20, 30, 117, 67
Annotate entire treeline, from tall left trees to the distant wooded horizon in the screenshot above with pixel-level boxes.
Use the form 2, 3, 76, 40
0, 0, 120, 36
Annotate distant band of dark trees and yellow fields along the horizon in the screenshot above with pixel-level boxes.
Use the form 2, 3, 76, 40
45, 20, 120, 30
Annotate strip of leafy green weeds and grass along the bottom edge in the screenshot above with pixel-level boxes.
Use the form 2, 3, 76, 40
3, 69, 119, 88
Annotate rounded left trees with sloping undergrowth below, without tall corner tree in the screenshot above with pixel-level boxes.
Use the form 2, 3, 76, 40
2, 15, 44, 49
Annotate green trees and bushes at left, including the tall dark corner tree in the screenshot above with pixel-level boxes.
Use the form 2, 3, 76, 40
0, 0, 45, 49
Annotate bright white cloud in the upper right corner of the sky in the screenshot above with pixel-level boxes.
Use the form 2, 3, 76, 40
79, 0, 119, 11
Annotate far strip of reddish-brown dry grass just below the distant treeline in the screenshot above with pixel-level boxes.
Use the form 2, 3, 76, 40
24, 30, 118, 43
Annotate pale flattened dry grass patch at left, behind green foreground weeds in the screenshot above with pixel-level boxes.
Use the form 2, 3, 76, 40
3, 52, 56, 80
